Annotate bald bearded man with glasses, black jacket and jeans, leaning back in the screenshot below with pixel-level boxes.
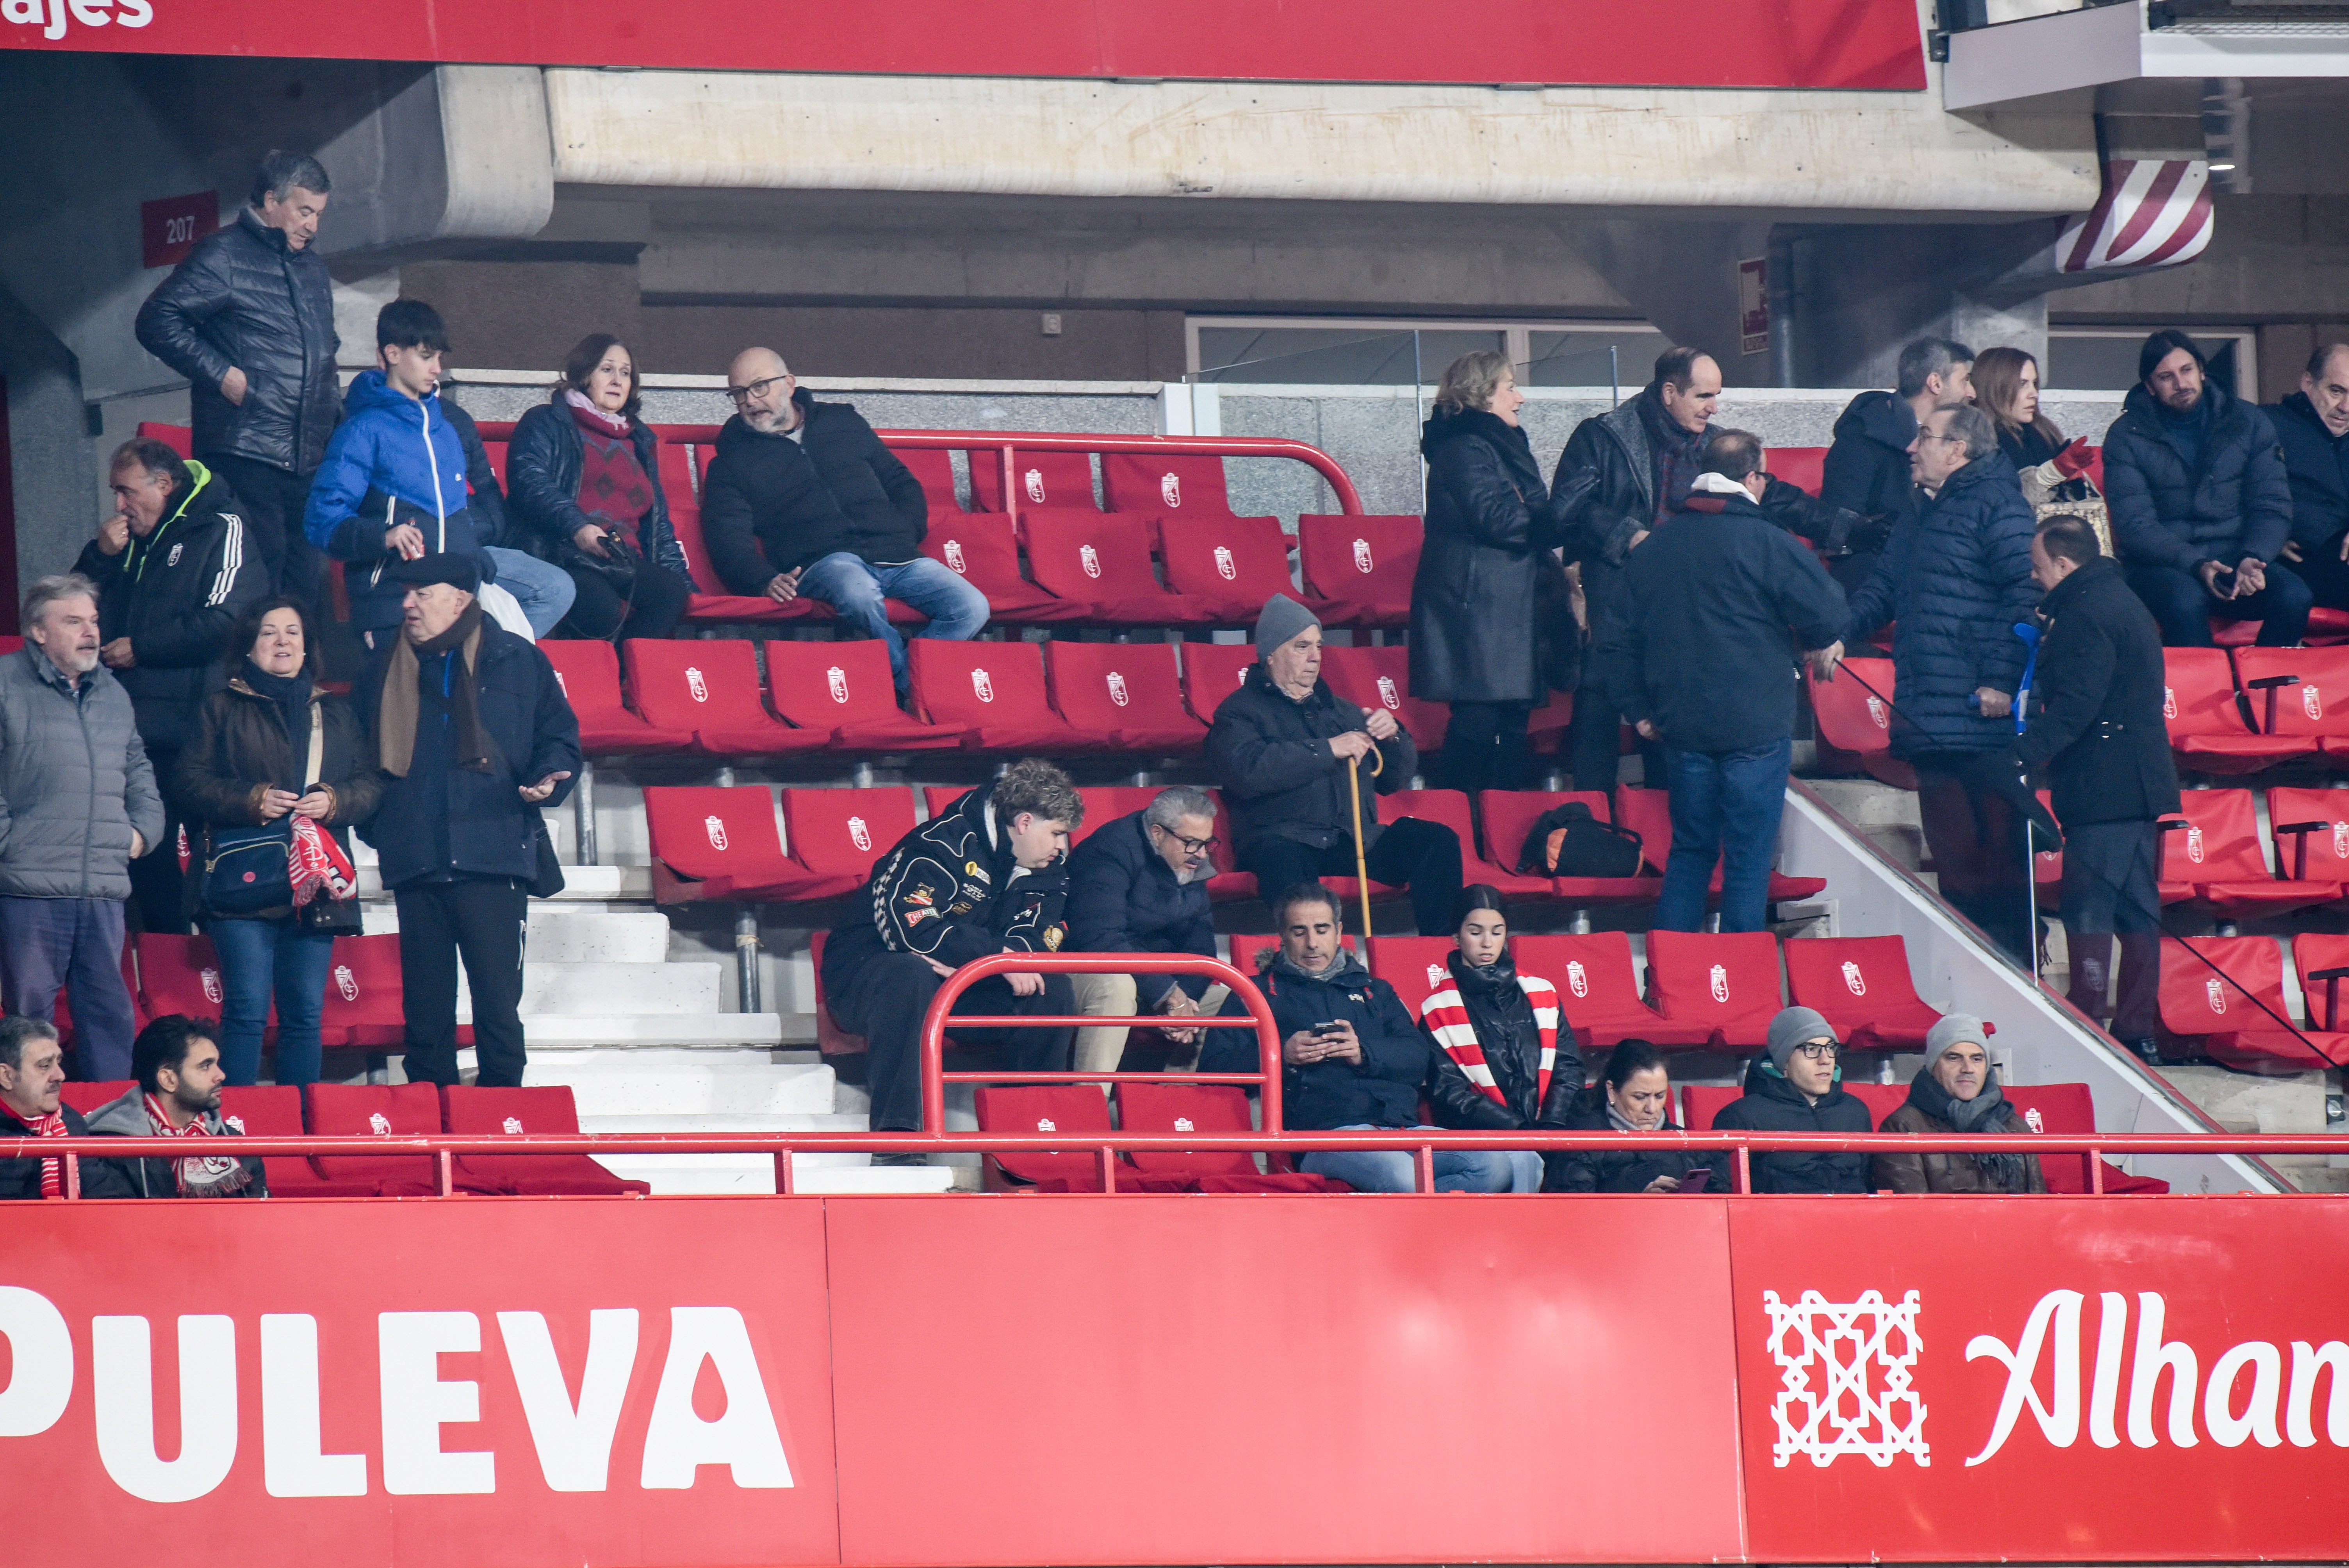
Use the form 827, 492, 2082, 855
702, 347, 987, 702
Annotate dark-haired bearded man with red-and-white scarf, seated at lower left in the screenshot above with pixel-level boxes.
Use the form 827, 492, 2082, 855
85, 1012, 270, 1197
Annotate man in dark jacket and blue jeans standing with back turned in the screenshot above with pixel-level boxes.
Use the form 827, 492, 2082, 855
1597, 429, 1846, 932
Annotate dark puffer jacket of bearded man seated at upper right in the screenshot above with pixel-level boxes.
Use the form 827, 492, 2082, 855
2105, 385, 2293, 573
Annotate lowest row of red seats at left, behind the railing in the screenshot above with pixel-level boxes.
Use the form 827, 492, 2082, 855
63, 1080, 651, 1197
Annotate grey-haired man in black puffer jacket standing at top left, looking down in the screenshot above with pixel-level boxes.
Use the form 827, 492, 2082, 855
134, 153, 340, 606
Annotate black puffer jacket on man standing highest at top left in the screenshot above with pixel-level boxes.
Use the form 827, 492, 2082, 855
132, 207, 340, 474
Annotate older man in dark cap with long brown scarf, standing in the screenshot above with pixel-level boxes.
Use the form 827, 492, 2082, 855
357, 554, 580, 1087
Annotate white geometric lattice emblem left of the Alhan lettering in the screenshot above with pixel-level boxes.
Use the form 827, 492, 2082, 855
1762, 1291, 1933, 1469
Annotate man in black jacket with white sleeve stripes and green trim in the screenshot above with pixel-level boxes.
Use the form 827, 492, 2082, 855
73, 437, 270, 932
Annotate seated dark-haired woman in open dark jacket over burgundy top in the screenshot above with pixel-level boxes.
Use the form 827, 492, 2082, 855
505, 331, 693, 641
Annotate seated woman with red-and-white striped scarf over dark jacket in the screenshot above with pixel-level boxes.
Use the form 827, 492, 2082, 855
1419, 883, 1583, 1192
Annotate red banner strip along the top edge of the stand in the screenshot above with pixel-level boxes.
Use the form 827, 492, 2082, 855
0, 0, 1924, 89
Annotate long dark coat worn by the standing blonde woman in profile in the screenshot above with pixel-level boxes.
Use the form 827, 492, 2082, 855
1412, 408, 1567, 704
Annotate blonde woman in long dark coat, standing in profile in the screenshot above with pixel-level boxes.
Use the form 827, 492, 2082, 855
1412, 352, 1574, 791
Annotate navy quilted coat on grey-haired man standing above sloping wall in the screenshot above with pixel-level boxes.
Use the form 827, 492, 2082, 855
1844, 451, 2039, 756
